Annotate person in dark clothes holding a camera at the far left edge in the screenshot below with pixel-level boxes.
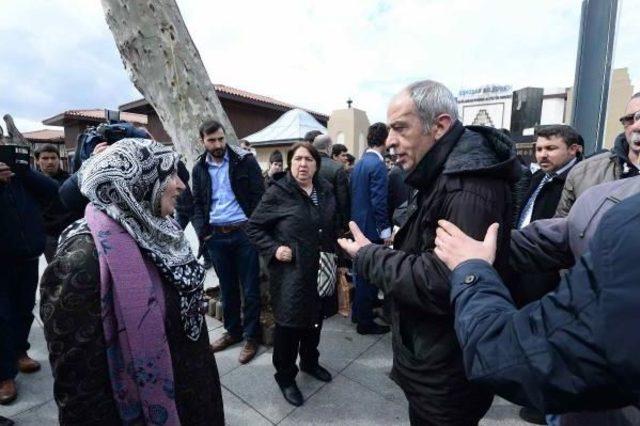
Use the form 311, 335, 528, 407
0, 145, 58, 405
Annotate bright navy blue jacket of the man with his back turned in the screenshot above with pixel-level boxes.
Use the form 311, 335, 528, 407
350, 152, 391, 241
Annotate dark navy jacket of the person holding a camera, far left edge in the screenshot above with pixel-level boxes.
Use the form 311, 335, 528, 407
0, 169, 58, 260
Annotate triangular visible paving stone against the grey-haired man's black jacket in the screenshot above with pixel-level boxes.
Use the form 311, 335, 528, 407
341, 332, 406, 406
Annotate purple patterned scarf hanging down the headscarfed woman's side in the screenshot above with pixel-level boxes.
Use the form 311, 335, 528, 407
85, 204, 180, 425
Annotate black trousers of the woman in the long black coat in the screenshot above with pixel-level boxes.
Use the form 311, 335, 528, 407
273, 319, 322, 386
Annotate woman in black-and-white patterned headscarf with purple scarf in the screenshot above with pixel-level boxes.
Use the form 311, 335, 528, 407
40, 139, 224, 425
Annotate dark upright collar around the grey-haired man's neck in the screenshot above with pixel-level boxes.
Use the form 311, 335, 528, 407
405, 120, 465, 189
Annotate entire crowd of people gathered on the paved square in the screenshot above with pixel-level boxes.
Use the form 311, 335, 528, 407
0, 80, 640, 426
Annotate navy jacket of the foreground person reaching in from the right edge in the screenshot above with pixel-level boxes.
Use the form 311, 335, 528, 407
451, 194, 640, 413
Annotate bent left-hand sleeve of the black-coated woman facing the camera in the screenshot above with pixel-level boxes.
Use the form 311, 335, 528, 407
245, 190, 281, 262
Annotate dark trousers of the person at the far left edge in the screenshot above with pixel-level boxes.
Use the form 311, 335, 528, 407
0, 258, 38, 380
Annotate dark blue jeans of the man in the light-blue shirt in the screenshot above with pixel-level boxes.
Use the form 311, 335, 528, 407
206, 229, 260, 339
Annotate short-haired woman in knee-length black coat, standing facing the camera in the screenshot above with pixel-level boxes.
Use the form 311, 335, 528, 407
246, 142, 336, 406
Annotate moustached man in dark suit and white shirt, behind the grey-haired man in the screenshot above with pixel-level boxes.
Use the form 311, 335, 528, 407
513, 124, 582, 306
